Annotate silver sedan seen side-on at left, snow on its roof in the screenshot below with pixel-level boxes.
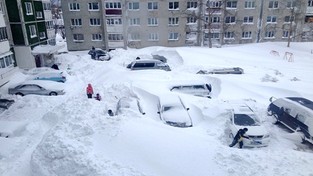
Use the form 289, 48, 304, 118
8, 80, 65, 96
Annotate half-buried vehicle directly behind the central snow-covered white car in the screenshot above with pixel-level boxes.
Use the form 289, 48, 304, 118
170, 82, 212, 98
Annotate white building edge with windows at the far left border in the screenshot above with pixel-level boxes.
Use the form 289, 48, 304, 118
0, 0, 17, 86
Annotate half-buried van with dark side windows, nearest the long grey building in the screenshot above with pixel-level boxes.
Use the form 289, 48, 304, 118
127, 60, 171, 71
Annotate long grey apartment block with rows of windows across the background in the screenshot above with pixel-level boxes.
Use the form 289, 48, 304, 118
62, 0, 312, 50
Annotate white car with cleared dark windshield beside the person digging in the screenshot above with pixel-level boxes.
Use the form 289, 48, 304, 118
227, 105, 270, 147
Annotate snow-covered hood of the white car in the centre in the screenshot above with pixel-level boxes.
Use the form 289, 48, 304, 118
162, 109, 190, 123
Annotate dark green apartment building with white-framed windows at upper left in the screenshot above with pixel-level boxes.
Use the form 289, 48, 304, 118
5, 0, 55, 69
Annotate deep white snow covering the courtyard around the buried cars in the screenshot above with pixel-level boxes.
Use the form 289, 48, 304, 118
0, 37, 313, 176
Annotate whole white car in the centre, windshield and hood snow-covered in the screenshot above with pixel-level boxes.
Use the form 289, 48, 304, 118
158, 94, 192, 127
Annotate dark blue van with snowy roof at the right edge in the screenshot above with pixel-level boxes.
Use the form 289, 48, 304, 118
267, 97, 313, 144
